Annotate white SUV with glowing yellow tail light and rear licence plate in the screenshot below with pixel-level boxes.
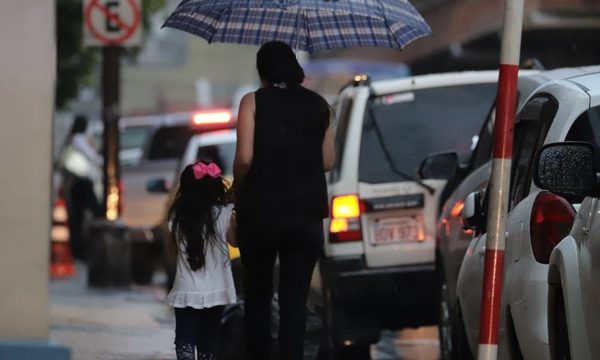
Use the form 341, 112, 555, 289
315, 71, 498, 359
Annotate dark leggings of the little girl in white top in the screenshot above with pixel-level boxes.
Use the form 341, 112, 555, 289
175, 305, 225, 360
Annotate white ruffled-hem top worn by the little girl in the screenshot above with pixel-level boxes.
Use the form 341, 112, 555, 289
167, 205, 236, 309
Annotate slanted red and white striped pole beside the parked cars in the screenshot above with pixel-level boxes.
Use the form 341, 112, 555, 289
477, 0, 524, 360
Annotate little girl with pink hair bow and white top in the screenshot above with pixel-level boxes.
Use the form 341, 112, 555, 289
167, 162, 236, 360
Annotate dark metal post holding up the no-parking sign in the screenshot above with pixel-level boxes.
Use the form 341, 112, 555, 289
102, 46, 121, 220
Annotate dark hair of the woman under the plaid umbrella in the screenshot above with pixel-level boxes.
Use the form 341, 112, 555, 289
256, 41, 304, 87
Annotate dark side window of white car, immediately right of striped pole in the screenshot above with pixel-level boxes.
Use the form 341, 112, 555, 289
509, 96, 558, 209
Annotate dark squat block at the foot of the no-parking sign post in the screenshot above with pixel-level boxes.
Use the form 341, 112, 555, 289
87, 219, 131, 287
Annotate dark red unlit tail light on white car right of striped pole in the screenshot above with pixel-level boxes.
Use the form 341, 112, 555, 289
530, 192, 575, 264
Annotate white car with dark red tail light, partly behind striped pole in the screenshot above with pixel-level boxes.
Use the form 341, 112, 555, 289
456, 67, 600, 359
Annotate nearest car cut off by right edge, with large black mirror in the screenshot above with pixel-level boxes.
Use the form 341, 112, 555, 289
535, 143, 600, 360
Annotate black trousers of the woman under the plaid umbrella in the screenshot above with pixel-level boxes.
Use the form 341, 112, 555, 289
238, 214, 323, 360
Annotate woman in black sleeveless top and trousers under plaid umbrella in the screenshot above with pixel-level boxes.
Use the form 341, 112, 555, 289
234, 41, 335, 360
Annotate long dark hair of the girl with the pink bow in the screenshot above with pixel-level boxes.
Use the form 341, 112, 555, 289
169, 161, 227, 271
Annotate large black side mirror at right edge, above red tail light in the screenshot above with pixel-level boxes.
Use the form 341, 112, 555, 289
533, 142, 598, 196
